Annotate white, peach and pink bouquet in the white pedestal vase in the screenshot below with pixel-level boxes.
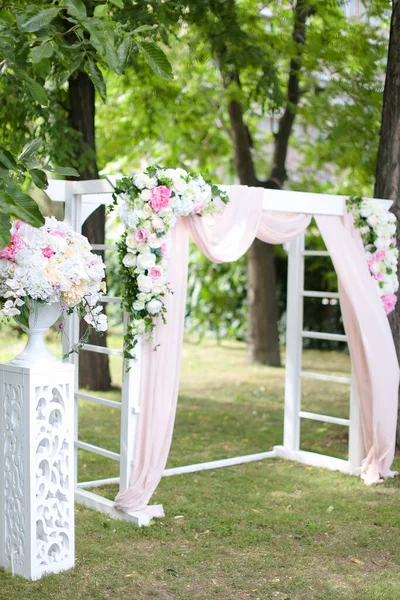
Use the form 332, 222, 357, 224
0, 217, 107, 342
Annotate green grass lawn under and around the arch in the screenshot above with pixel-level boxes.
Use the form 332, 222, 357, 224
0, 334, 400, 600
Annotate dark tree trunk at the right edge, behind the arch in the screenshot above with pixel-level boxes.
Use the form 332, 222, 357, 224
374, 0, 400, 448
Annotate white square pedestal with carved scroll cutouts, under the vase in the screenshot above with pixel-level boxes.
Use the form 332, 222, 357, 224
0, 361, 75, 580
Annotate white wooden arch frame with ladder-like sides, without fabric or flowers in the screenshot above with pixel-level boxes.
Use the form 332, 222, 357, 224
47, 178, 391, 526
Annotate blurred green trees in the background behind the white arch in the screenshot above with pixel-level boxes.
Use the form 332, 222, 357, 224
98, 0, 390, 362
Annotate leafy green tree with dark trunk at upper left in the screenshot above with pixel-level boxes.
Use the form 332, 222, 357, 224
0, 0, 172, 389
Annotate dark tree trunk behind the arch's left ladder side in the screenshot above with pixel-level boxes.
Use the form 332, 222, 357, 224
69, 73, 111, 391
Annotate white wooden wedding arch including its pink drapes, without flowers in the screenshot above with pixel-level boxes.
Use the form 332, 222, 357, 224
47, 179, 398, 526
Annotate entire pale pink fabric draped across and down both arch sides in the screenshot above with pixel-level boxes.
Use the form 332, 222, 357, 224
115, 186, 399, 516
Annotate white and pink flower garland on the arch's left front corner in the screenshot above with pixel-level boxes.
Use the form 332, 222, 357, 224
112, 166, 228, 358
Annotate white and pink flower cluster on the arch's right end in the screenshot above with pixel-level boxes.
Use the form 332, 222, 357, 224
346, 197, 399, 315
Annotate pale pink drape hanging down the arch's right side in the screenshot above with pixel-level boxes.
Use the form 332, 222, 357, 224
315, 213, 399, 484
